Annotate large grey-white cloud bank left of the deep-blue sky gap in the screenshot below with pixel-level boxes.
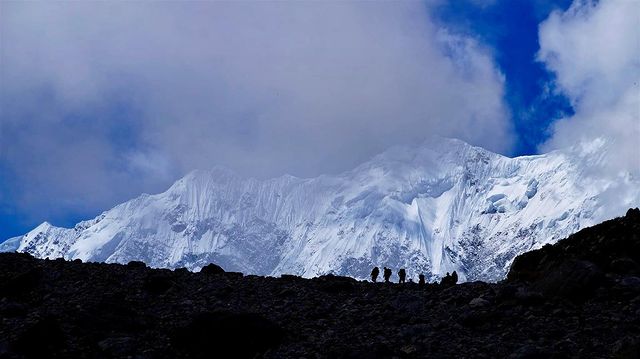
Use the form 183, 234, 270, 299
0, 2, 510, 224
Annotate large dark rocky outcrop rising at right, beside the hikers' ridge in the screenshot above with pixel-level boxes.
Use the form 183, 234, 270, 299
507, 208, 640, 301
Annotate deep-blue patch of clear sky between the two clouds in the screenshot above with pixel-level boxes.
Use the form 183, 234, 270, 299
435, 0, 572, 155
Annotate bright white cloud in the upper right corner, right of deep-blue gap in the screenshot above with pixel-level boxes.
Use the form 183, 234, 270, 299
538, 0, 640, 176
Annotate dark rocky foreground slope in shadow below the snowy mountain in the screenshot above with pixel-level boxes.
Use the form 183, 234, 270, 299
0, 209, 640, 358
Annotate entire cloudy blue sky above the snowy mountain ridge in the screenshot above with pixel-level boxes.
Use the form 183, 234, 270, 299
0, 0, 640, 241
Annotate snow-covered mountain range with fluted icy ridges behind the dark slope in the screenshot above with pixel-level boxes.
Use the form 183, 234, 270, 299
1, 138, 640, 281
